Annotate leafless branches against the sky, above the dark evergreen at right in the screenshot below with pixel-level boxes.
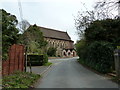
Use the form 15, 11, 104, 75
75, 0, 120, 38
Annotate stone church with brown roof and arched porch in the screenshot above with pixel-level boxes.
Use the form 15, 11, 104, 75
39, 27, 76, 57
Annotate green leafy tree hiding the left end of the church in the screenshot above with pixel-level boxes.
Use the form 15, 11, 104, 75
21, 25, 47, 53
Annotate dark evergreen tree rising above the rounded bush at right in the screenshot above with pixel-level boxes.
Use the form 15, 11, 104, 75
85, 18, 120, 46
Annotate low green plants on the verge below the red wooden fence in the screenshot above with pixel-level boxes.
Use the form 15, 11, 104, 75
2, 71, 40, 88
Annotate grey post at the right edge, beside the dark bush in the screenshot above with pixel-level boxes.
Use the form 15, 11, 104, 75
114, 48, 120, 89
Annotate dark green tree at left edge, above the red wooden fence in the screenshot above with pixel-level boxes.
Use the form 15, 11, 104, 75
0, 9, 19, 60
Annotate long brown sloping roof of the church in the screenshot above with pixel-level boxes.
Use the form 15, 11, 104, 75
39, 27, 73, 42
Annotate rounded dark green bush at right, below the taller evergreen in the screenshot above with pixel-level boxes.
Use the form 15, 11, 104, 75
80, 41, 114, 73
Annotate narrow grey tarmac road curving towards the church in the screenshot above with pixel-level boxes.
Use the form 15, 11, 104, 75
36, 58, 118, 88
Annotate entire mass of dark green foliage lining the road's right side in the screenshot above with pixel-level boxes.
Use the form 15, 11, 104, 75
76, 18, 120, 73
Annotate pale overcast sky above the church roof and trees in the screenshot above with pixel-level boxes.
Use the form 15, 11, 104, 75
0, 0, 95, 42
